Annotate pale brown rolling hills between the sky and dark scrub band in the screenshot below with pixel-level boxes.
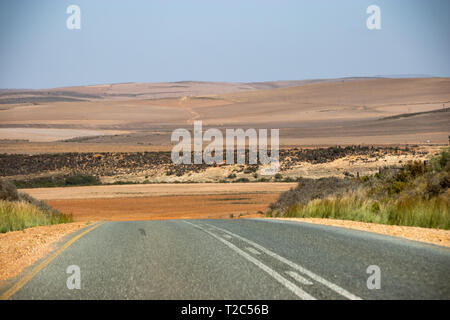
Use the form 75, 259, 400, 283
0, 78, 450, 146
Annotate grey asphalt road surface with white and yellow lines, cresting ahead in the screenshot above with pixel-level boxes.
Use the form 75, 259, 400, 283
7, 219, 450, 299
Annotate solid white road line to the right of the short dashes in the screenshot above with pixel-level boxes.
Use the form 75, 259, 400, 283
207, 224, 362, 300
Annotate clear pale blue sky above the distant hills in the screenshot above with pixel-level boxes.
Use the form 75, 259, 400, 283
0, 0, 450, 88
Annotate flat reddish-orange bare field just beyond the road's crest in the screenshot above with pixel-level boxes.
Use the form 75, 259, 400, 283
47, 193, 279, 221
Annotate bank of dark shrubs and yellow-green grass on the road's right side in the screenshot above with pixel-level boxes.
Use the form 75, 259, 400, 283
267, 149, 450, 230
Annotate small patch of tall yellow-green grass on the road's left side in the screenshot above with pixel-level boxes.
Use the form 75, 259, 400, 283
0, 200, 73, 233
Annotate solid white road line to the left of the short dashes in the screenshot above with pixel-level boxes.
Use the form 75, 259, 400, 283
184, 221, 316, 300
